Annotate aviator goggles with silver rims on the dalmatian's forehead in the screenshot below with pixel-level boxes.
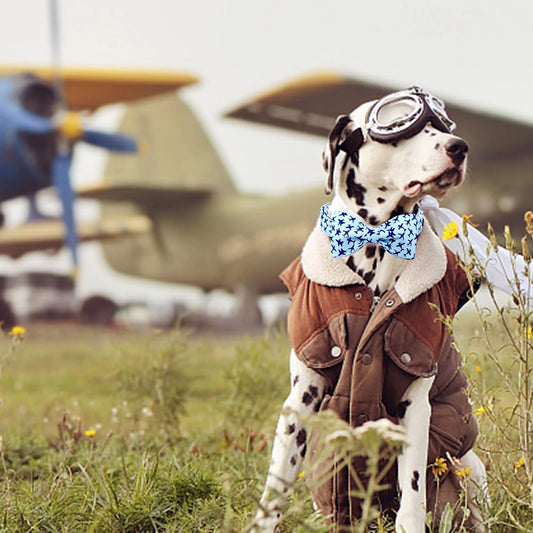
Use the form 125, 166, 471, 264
366, 87, 455, 143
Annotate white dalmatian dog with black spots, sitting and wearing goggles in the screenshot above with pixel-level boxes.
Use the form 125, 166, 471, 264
251, 87, 486, 533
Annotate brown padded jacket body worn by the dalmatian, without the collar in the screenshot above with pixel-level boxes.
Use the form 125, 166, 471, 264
281, 247, 478, 525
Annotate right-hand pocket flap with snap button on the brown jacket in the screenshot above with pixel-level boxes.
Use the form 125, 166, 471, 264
385, 318, 437, 377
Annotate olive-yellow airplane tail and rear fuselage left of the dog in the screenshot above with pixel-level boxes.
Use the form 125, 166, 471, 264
78, 94, 321, 300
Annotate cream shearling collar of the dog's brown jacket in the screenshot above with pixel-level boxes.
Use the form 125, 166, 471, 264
302, 213, 446, 303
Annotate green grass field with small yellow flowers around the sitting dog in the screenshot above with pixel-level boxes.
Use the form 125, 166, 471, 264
0, 315, 533, 533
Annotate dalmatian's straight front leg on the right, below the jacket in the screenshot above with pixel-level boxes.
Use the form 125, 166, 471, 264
395, 376, 435, 533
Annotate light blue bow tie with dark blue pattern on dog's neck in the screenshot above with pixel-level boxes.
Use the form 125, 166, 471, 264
320, 204, 424, 259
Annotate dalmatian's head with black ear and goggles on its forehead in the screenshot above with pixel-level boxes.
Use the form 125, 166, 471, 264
323, 88, 468, 225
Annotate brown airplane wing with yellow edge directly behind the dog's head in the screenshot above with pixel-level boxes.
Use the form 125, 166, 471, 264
226, 72, 533, 161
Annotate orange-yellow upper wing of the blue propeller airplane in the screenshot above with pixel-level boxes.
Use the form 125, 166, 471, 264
0, 65, 198, 110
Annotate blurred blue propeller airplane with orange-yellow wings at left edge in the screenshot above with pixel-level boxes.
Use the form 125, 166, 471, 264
0, 66, 197, 265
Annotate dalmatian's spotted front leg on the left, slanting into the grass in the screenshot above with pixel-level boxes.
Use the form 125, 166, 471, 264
251, 350, 325, 533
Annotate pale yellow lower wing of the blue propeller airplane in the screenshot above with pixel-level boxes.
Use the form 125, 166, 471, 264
0, 215, 152, 258
